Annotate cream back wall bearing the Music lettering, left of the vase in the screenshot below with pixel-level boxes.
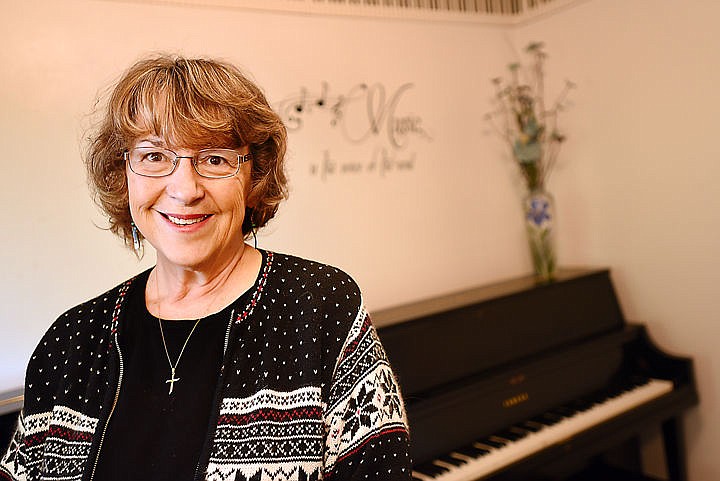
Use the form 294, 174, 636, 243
0, 0, 516, 382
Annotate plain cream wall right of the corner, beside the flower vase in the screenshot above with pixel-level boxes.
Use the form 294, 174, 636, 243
514, 0, 720, 481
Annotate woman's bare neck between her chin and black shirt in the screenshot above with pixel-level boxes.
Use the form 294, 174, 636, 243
145, 244, 262, 319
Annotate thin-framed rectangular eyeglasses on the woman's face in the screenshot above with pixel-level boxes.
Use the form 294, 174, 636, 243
123, 146, 251, 179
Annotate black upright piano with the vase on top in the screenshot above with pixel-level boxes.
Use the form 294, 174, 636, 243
372, 269, 698, 481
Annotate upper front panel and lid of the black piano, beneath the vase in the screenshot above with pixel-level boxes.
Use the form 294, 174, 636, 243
372, 270, 625, 395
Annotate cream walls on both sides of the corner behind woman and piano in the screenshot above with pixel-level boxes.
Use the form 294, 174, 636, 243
0, 0, 720, 481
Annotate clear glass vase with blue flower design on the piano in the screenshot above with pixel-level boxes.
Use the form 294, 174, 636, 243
524, 188, 556, 282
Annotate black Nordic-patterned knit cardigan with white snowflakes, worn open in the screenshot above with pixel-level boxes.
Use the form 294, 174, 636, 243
0, 251, 410, 481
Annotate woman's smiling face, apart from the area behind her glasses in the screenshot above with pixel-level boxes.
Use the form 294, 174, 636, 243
126, 136, 251, 270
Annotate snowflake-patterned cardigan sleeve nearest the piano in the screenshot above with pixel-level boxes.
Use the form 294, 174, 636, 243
324, 307, 411, 481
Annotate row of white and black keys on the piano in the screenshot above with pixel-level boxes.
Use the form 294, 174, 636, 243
413, 379, 673, 481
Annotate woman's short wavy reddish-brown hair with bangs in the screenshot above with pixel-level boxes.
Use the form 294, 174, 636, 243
84, 55, 287, 246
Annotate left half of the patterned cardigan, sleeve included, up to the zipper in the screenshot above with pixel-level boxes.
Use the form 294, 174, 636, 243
0, 283, 129, 481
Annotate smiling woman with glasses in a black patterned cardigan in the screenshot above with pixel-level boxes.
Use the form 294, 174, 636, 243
0, 57, 410, 481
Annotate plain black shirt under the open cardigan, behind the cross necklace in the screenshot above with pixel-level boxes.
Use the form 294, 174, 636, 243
95, 274, 238, 481
